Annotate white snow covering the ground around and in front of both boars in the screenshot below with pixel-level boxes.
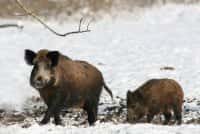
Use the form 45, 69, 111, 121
0, 5, 200, 134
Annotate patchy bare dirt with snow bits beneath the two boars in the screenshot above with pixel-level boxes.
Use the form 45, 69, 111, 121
0, 97, 200, 128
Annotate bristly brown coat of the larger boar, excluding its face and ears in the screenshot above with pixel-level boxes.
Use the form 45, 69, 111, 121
25, 50, 112, 125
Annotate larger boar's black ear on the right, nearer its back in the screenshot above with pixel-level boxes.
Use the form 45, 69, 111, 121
47, 51, 59, 67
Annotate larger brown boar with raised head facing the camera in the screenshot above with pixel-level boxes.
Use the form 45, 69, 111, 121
25, 50, 112, 125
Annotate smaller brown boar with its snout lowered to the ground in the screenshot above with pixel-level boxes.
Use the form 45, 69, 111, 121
127, 79, 183, 124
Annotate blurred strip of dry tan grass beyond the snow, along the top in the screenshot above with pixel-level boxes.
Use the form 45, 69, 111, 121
0, 0, 200, 18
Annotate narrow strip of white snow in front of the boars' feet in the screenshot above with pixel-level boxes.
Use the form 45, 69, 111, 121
0, 123, 200, 134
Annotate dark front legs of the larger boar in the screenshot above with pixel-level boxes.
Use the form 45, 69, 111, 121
40, 91, 65, 125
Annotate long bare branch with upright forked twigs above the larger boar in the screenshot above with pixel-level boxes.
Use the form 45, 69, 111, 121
15, 0, 91, 37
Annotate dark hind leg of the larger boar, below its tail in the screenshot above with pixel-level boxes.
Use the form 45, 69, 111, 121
84, 100, 98, 125
